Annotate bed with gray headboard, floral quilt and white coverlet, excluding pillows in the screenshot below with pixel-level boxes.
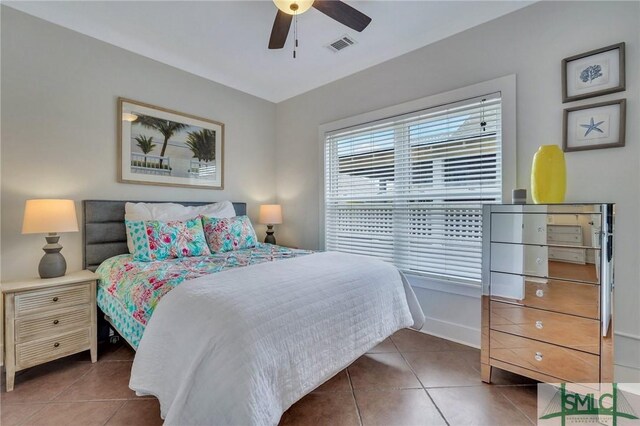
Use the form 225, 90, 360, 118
83, 201, 424, 425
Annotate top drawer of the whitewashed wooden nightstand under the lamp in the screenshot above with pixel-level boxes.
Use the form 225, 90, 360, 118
15, 283, 91, 316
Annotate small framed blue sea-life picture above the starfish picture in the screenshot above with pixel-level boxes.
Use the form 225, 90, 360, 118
562, 42, 626, 103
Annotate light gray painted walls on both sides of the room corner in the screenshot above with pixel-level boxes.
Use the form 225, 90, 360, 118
0, 2, 640, 381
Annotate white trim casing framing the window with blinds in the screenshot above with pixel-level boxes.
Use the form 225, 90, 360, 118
318, 74, 517, 270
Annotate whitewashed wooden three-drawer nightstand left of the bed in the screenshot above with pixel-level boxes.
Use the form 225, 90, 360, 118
2, 271, 98, 392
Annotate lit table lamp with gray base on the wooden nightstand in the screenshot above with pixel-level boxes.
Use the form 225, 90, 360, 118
22, 200, 78, 278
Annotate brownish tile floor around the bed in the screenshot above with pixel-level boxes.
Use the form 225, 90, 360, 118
0, 330, 536, 426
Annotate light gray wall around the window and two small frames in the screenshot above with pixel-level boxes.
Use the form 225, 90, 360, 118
276, 2, 640, 380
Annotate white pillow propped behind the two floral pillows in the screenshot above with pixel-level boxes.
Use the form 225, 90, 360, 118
124, 201, 236, 254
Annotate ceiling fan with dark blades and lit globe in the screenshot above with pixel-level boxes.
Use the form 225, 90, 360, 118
269, 0, 371, 49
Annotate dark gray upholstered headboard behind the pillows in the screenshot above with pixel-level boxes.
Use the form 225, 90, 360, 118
82, 200, 247, 271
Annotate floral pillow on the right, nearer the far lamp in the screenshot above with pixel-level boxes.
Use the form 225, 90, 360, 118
202, 216, 257, 253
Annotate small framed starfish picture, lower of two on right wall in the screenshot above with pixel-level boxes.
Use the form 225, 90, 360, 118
562, 99, 627, 152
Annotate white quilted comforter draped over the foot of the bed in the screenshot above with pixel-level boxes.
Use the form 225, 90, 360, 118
129, 252, 424, 425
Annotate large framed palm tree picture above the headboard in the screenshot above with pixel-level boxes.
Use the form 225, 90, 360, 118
118, 98, 224, 189
